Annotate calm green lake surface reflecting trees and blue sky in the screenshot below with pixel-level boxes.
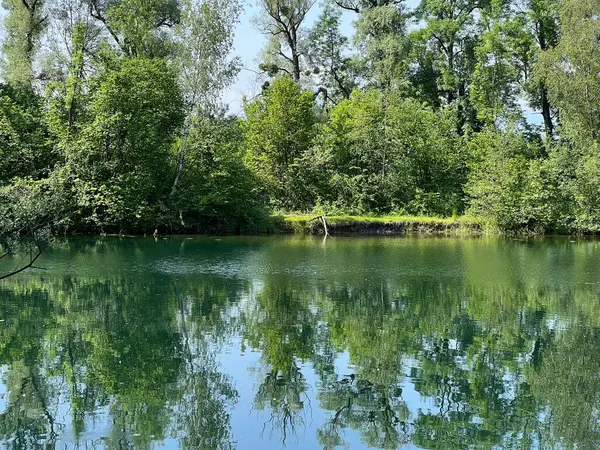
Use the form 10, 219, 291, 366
0, 237, 600, 450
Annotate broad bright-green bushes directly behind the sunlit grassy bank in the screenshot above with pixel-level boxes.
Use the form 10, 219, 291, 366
325, 90, 465, 215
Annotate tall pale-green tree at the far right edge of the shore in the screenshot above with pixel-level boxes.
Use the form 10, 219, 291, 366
538, 0, 600, 230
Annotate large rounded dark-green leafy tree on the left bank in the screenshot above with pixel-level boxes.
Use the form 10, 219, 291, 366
67, 59, 183, 231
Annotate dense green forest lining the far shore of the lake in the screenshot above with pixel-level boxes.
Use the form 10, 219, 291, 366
0, 0, 600, 237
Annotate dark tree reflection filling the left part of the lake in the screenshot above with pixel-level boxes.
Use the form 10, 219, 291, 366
0, 270, 237, 449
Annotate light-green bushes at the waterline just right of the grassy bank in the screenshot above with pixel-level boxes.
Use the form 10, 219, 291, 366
465, 128, 575, 233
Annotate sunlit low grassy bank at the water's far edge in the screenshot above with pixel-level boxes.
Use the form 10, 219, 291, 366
273, 215, 485, 234
